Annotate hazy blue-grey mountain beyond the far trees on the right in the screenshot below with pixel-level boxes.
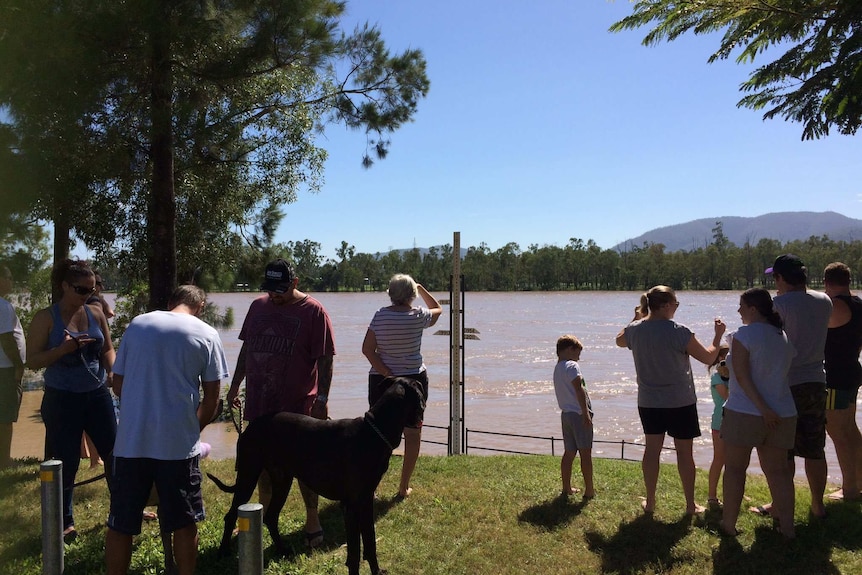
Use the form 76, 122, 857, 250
613, 212, 862, 252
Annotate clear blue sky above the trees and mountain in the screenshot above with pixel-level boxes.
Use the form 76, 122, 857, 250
276, 0, 862, 258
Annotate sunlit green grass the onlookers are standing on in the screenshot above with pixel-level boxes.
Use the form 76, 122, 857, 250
0, 456, 862, 575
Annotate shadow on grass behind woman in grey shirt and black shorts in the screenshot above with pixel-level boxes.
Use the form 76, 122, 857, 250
584, 514, 692, 574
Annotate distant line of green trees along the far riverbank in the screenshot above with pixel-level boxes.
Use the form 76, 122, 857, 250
123, 221, 862, 292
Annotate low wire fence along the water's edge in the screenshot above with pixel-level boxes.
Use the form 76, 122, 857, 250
422, 424, 676, 461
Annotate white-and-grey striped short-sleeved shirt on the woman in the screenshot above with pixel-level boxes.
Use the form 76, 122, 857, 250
368, 307, 433, 375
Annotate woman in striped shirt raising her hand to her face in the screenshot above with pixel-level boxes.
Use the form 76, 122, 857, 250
362, 274, 443, 499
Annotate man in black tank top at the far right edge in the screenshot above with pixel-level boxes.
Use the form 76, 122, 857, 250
823, 262, 862, 500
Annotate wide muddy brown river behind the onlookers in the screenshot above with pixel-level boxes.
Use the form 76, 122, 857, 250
12, 291, 860, 482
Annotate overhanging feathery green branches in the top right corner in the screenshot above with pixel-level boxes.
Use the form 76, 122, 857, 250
611, 0, 862, 139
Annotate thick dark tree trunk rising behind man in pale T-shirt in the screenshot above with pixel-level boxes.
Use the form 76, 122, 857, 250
147, 0, 177, 310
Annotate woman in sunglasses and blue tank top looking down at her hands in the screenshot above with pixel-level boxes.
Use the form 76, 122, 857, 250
27, 260, 117, 542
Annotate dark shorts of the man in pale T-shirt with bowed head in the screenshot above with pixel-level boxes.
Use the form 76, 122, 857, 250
108, 457, 205, 535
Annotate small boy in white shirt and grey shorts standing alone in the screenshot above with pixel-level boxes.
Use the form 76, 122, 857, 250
554, 335, 596, 499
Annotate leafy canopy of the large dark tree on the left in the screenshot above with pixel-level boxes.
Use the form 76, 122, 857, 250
0, 0, 429, 308
